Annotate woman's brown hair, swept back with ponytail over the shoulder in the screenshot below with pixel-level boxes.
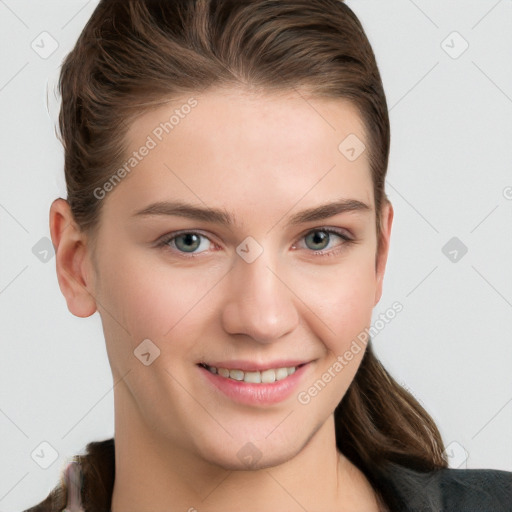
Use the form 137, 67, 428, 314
59, 0, 447, 506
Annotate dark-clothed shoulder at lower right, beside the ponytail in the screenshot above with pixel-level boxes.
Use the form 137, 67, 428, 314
387, 465, 512, 512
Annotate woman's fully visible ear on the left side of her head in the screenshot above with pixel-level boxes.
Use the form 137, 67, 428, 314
50, 198, 96, 318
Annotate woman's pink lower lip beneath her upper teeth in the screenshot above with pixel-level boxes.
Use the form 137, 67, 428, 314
198, 363, 310, 405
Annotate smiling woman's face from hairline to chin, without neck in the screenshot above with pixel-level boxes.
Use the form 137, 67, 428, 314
73, 90, 392, 468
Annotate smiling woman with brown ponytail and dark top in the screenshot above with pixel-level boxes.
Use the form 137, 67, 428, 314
25, 0, 512, 512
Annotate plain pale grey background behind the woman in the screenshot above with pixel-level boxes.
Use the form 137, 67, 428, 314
0, 0, 512, 512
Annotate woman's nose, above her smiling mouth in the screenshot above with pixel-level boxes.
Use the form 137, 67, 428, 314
222, 251, 299, 343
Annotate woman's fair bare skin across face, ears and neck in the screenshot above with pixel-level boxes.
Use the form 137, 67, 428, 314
50, 89, 393, 512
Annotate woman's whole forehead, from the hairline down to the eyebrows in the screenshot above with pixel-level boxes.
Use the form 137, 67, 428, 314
112, 89, 373, 221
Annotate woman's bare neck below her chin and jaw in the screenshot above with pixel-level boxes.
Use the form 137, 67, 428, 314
111, 386, 378, 512
